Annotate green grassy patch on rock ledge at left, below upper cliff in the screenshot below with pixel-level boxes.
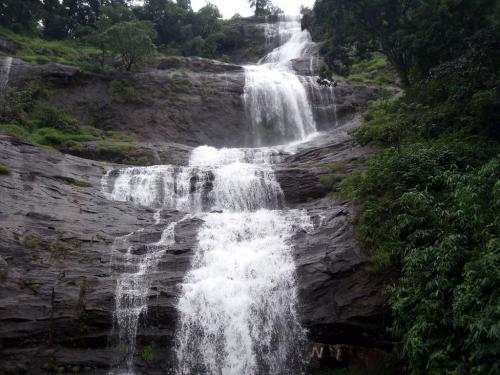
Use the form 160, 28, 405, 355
0, 87, 148, 165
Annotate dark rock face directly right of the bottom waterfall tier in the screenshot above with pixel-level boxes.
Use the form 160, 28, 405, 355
295, 199, 386, 347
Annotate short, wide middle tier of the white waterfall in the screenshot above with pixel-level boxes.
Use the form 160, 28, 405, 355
102, 146, 282, 213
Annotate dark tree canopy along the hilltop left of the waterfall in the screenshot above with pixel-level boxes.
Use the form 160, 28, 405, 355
0, 0, 281, 69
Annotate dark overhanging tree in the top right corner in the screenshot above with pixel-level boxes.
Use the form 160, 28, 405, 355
312, 0, 498, 86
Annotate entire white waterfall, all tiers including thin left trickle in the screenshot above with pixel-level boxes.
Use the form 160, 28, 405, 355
103, 13, 330, 375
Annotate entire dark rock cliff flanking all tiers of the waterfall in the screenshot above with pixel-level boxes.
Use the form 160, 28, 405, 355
0, 18, 387, 375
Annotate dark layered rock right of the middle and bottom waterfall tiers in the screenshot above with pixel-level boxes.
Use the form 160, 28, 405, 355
276, 125, 388, 360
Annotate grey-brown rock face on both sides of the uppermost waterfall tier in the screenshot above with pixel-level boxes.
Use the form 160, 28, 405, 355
0, 53, 377, 151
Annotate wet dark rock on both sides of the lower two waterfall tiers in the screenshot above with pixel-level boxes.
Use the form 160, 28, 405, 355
0, 116, 387, 374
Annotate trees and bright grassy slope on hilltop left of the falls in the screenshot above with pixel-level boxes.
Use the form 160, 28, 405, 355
0, 0, 258, 73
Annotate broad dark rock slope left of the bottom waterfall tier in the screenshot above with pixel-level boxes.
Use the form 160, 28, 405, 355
0, 137, 199, 374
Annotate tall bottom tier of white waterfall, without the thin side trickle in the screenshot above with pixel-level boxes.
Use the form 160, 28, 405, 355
177, 209, 309, 375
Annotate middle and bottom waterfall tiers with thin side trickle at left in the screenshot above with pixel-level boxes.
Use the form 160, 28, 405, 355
103, 146, 310, 375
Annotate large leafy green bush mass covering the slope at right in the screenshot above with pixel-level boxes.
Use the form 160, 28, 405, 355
341, 95, 500, 375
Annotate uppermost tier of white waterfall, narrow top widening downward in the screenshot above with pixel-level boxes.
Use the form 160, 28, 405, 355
243, 16, 316, 146
